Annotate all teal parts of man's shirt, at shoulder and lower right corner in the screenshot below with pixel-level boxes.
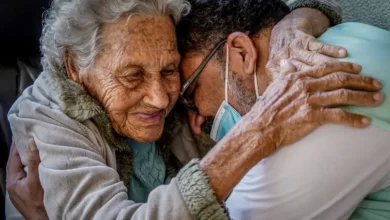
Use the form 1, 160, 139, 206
319, 23, 390, 220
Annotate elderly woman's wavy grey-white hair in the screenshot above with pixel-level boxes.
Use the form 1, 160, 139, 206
41, 0, 190, 74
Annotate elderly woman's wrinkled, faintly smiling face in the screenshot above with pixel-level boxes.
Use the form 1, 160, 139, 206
80, 16, 180, 142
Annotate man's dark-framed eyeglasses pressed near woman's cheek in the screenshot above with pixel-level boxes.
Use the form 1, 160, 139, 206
180, 40, 226, 114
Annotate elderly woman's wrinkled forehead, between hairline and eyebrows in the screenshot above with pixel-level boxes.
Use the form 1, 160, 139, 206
104, 16, 177, 52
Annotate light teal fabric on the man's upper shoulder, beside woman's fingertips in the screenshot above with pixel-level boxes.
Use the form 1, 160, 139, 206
319, 23, 390, 130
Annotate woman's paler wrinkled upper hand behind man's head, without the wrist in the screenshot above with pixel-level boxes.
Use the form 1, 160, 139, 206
266, 13, 347, 79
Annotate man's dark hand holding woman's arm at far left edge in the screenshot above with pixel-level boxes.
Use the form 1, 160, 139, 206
7, 139, 49, 220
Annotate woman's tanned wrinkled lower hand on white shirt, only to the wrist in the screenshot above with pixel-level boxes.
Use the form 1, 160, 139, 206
237, 61, 383, 158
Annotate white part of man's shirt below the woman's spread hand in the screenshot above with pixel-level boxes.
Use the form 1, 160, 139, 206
227, 125, 390, 220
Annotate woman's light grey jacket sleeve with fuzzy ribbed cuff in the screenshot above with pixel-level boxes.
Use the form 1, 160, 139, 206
8, 82, 219, 220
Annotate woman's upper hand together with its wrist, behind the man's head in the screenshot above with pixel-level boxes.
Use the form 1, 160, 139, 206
266, 8, 347, 80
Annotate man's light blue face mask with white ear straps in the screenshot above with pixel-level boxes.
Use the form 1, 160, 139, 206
210, 46, 261, 142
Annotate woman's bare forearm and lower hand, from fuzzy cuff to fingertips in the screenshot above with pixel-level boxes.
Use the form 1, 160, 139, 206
200, 61, 383, 201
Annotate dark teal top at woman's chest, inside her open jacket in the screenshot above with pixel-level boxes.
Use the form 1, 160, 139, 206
129, 140, 168, 203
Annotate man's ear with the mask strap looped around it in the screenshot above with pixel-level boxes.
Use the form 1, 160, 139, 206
226, 32, 257, 74
